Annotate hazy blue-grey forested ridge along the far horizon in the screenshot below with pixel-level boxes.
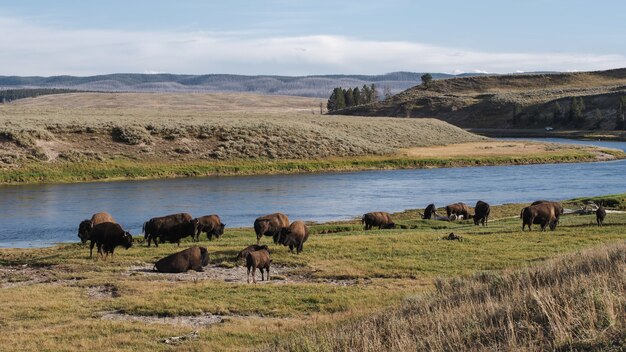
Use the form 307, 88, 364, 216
0, 72, 468, 98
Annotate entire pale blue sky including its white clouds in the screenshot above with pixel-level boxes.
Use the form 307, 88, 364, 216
0, 0, 626, 76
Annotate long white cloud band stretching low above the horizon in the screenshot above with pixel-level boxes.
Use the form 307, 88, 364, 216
0, 18, 626, 76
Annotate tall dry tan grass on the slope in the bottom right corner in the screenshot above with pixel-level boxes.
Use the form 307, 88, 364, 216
269, 243, 626, 351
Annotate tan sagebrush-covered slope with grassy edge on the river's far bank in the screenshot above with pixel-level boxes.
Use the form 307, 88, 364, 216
0, 93, 623, 183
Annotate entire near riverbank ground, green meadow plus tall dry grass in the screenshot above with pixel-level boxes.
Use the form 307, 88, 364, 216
0, 195, 626, 351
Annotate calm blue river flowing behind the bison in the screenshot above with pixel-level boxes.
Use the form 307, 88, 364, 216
0, 139, 626, 247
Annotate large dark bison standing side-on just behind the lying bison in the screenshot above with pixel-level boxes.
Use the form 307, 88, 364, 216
143, 213, 197, 247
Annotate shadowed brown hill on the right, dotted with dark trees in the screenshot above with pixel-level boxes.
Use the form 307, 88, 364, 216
335, 68, 626, 130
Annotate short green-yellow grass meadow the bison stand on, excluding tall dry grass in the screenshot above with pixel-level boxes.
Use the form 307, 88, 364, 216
0, 195, 626, 351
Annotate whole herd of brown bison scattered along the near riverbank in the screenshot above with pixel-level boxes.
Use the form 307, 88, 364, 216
78, 200, 606, 283
